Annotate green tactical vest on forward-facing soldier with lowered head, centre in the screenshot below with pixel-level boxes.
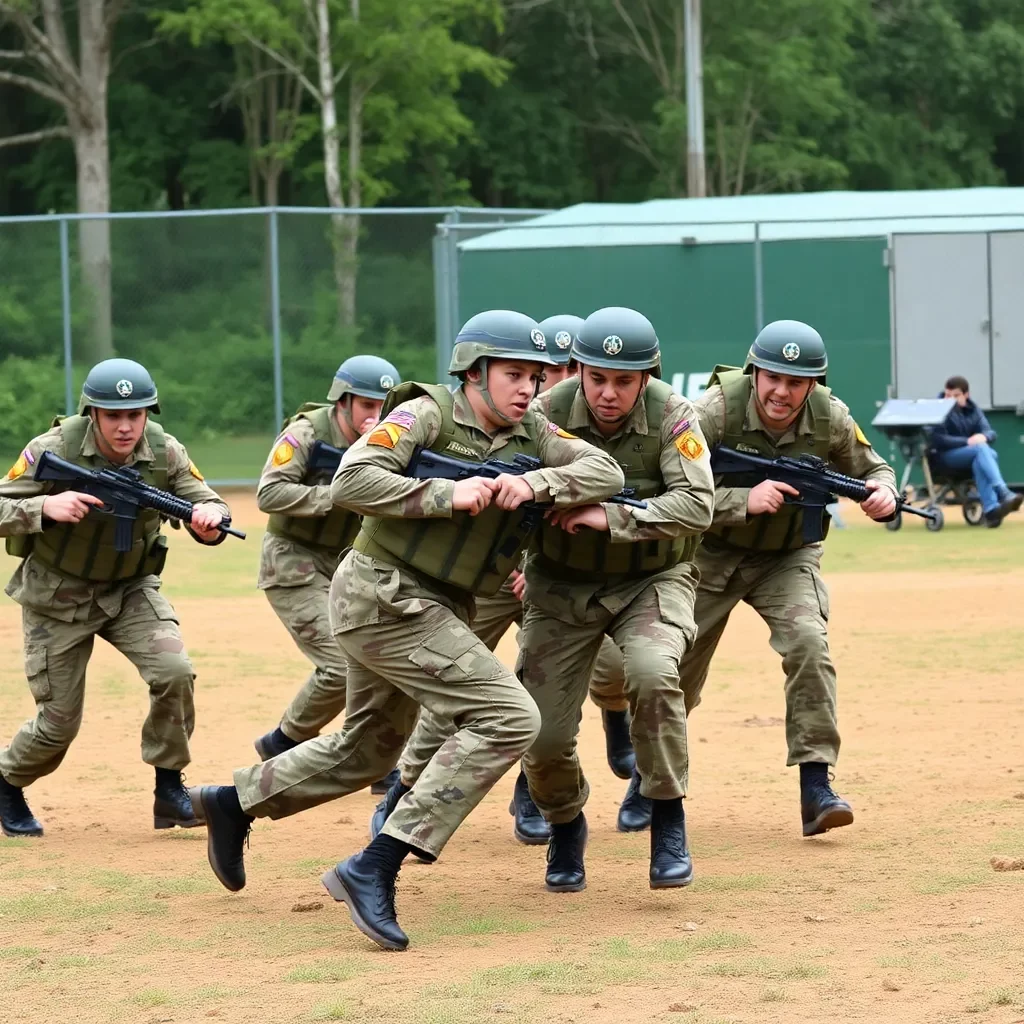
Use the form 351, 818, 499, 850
538, 378, 700, 580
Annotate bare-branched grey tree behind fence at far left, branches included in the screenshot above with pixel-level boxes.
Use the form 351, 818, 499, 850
0, 0, 127, 359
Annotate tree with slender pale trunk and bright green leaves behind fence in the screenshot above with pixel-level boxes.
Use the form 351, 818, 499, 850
162, 0, 503, 327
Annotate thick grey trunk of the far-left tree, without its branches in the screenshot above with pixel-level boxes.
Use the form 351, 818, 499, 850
70, 0, 114, 361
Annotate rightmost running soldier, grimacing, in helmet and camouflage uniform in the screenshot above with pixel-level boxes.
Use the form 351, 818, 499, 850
681, 321, 896, 836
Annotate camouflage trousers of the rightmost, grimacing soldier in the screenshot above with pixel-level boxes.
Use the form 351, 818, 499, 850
680, 538, 840, 765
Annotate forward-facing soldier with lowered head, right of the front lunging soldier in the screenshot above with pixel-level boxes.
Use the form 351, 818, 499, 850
517, 307, 714, 892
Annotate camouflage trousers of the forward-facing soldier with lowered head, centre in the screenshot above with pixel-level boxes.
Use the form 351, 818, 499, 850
516, 562, 697, 824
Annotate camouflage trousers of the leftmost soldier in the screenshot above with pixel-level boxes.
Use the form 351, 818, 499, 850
0, 577, 196, 786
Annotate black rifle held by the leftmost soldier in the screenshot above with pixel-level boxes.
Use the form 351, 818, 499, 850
33, 452, 246, 552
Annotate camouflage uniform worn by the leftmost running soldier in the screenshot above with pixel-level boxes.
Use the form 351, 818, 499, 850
0, 417, 228, 786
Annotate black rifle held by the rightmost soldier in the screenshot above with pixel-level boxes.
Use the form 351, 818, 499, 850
711, 445, 936, 544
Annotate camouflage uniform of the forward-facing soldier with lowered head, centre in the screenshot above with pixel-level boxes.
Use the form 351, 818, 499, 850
517, 376, 713, 824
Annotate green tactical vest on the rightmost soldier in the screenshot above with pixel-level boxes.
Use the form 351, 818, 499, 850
708, 367, 831, 551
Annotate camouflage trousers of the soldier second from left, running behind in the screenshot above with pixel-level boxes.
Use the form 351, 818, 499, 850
263, 572, 346, 741
